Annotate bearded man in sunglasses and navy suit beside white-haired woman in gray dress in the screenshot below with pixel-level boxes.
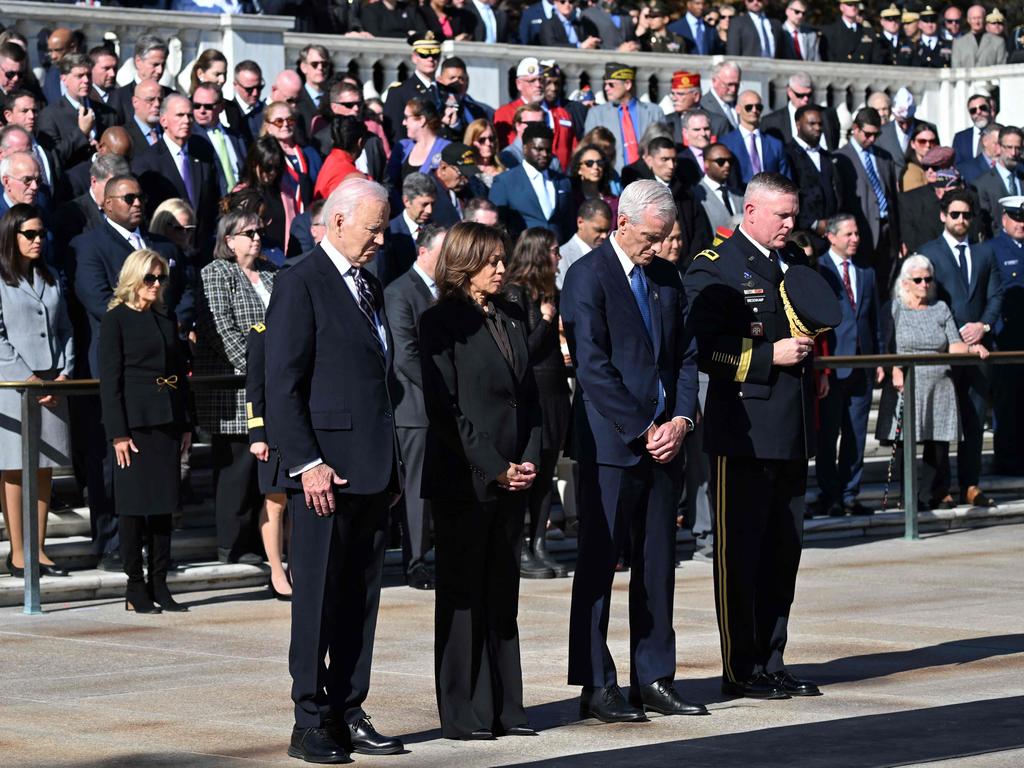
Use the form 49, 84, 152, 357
921, 189, 1002, 507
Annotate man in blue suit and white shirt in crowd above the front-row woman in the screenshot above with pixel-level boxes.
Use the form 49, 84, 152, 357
488, 123, 572, 243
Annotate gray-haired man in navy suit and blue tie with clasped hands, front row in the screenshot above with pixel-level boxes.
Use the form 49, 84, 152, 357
561, 179, 707, 723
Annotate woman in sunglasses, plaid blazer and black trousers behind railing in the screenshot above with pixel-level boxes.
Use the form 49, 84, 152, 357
195, 211, 276, 562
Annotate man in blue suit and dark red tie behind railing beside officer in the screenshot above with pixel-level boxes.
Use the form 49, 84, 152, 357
815, 213, 883, 517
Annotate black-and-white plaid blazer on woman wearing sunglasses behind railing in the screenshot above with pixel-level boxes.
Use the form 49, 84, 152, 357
194, 259, 278, 434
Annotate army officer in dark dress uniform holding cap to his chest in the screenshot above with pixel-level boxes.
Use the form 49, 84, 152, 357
683, 173, 839, 698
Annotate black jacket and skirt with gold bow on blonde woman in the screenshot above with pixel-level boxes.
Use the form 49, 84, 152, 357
99, 304, 189, 516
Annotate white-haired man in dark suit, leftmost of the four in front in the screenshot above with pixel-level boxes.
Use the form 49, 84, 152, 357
266, 178, 402, 763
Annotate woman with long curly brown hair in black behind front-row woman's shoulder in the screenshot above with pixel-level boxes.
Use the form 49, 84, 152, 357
502, 226, 569, 579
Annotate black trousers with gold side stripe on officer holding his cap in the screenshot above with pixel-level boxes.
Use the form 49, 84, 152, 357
712, 456, 807, 682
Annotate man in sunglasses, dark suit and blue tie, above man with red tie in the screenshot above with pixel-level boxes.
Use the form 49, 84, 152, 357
835, 106, 899, 292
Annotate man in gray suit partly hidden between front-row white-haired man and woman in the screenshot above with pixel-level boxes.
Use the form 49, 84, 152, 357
384, 223, 447, 590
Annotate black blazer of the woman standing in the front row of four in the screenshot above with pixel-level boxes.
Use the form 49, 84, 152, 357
420, 297, 541, 502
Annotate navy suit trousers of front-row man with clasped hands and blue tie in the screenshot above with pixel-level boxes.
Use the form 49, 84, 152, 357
568, 452, 683, 688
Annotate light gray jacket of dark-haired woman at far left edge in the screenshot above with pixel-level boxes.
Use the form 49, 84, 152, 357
0, 274, 75, 381
